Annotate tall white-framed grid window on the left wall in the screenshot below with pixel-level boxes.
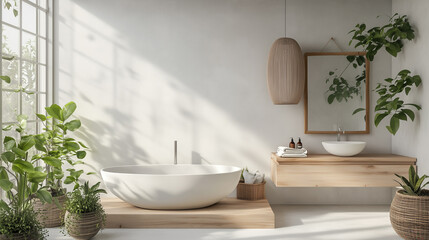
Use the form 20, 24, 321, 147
0, 0, 52, 139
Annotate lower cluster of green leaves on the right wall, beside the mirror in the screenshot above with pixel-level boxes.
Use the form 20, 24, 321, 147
374, 70, 422, 135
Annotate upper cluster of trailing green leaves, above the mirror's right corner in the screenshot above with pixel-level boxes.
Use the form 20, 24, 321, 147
349, 13, 415, 61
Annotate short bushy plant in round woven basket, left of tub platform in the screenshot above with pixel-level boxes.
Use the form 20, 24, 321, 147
64, 181, 106, 240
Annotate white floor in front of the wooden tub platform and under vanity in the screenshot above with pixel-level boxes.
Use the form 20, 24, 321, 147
48, 205, 400, 240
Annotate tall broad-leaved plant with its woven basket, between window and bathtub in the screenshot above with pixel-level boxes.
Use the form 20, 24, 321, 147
34, 102, 87, 227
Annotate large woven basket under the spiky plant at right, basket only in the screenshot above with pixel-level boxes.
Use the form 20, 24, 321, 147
390, 190, 429, 240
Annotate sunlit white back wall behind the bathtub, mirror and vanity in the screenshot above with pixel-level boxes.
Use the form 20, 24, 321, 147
55, 0, 391, 204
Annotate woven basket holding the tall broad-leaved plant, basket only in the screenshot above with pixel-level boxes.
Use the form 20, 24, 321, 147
33, 195, 67, 228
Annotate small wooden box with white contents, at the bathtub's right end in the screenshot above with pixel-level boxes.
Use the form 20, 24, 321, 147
237, 168, 265, 200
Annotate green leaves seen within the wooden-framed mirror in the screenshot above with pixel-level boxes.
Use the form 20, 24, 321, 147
325, 55, 366, 104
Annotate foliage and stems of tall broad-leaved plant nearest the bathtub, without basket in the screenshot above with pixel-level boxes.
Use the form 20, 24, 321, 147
35, 102, 87, 196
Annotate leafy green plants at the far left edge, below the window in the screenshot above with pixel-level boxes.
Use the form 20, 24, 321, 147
0, 115, 52, 239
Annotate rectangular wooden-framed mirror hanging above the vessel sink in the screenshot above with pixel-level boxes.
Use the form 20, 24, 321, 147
304, 52, 370, 134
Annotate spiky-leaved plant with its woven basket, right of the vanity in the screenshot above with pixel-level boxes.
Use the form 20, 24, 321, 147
390, 166, 429, 240
